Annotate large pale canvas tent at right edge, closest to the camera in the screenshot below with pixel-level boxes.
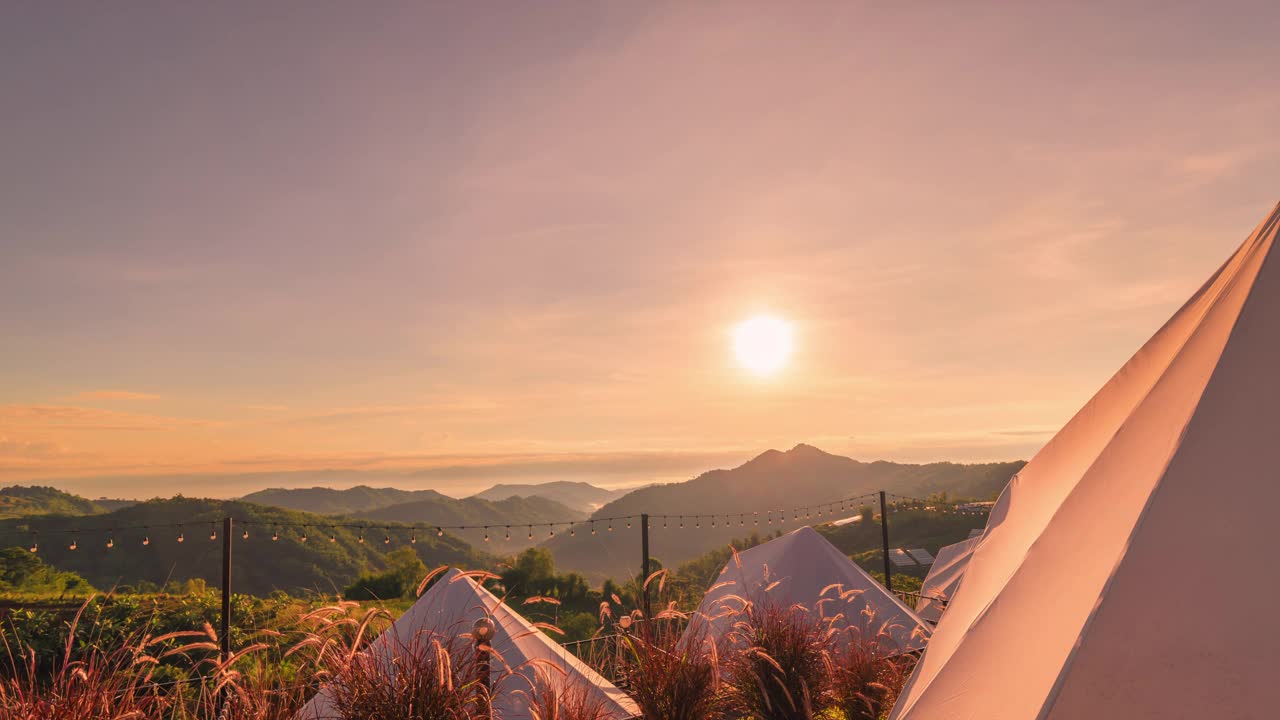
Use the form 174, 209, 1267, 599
892, 199, 1280, 720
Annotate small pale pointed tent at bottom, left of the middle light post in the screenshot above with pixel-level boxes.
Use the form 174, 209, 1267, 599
294, 569, 640, 720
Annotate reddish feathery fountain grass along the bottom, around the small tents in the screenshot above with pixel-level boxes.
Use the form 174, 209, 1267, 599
0, 571, 911, 720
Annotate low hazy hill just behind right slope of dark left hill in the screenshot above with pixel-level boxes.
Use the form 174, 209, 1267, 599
355, 495, 588, 553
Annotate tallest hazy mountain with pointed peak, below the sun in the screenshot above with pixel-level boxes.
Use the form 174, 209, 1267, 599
544, 445, 1025, 578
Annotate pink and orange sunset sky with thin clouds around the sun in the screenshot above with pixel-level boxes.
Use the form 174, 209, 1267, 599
0, 3, 1280, 497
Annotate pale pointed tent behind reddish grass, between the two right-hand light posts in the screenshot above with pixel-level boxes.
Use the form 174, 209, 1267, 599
685, 528, 929, 652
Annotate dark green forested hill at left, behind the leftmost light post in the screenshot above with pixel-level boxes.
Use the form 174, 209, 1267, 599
0, 497, 492, 594
